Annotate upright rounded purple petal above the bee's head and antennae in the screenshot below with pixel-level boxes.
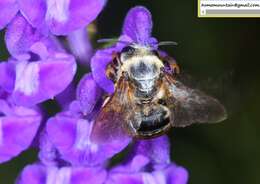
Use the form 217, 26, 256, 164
123, 6, 153, 45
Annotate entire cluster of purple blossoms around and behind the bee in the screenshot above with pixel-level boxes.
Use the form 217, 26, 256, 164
0, 0, 188, 184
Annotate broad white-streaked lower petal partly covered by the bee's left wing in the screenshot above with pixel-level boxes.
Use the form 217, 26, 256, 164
47, 115, 128, 166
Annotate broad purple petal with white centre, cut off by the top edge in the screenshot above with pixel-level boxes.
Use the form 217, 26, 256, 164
19, 0, 106, 35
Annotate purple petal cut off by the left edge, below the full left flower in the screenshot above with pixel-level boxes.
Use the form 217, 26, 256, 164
0, 100, 41, 163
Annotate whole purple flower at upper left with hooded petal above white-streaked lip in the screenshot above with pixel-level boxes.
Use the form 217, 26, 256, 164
2, 15, 76, 106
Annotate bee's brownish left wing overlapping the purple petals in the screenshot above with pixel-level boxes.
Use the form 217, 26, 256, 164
91, 77, 133, 144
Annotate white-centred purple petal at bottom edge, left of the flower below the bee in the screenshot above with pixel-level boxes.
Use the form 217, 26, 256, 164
17, 164, 106, 184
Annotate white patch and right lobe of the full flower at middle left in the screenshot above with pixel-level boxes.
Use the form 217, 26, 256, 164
13, 53, 76, 106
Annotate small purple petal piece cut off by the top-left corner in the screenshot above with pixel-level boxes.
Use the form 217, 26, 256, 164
0, 0, 18, 30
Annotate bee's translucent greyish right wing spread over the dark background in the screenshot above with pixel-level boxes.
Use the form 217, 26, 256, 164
166, 74, 227, 127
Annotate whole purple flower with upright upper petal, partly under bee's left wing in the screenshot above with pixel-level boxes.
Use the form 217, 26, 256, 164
42, 75, 129, 166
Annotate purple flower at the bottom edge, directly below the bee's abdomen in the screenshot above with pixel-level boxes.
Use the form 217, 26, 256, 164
107, 136, 188, 184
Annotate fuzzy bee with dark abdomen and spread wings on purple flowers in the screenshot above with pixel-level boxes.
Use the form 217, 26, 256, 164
92, 44, 227, 142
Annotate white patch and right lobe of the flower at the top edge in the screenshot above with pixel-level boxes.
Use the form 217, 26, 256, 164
45, 0, 106, 35
